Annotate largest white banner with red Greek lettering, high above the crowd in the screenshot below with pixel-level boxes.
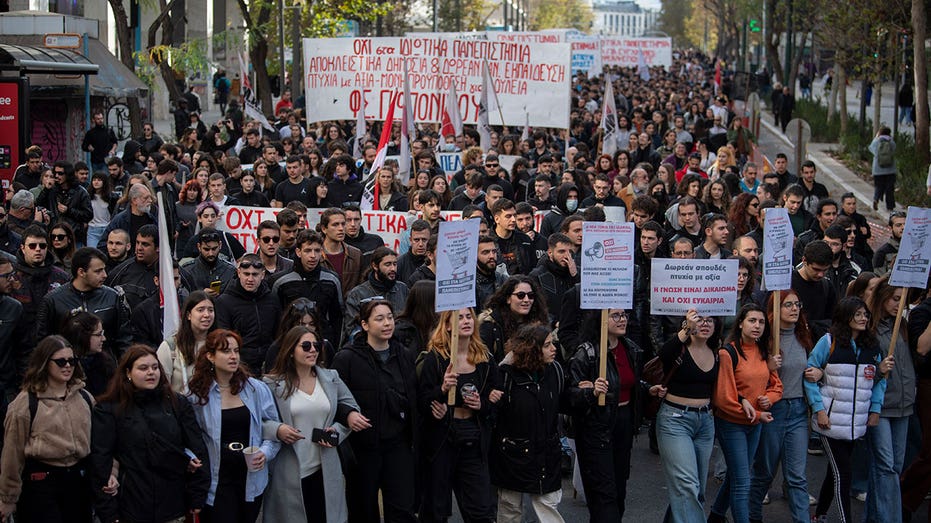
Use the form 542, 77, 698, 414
304, 36, 572, 129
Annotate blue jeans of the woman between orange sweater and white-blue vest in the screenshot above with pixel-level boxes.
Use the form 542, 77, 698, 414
750, 398, 810, 523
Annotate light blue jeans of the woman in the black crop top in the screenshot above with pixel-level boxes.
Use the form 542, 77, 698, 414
656, 402, 714, 523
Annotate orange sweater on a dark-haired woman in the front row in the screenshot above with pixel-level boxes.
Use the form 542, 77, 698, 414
713, 343, 782, 425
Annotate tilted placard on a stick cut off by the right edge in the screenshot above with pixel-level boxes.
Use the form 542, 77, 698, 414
889, 207, 931, 289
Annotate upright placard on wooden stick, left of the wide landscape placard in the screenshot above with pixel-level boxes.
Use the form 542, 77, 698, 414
581, 222, 634, 309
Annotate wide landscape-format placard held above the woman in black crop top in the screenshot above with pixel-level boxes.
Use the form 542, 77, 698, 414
652, 258, 738, 316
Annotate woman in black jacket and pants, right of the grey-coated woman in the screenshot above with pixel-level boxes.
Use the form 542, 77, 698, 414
332, 300, 419, 523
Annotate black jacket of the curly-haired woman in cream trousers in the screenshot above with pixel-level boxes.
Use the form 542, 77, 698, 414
489, 362, 567, 494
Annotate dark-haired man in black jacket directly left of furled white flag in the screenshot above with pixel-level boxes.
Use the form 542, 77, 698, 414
107, 224, 158, 311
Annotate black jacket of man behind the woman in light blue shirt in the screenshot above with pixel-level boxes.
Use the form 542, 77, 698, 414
216, 278, 281, 374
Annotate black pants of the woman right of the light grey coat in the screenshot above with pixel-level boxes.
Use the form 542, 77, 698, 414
346, 441, 416, 523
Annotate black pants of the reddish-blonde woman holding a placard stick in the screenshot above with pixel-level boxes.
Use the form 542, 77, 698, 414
420, 419, 495, 523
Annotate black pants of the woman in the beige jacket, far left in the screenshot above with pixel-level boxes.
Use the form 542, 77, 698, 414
16, 460, 93, 523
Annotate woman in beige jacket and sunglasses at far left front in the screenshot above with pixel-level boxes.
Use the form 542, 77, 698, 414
0, 336, 95, 523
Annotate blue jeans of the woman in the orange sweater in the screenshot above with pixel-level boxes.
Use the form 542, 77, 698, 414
711, 418, 762, 523
